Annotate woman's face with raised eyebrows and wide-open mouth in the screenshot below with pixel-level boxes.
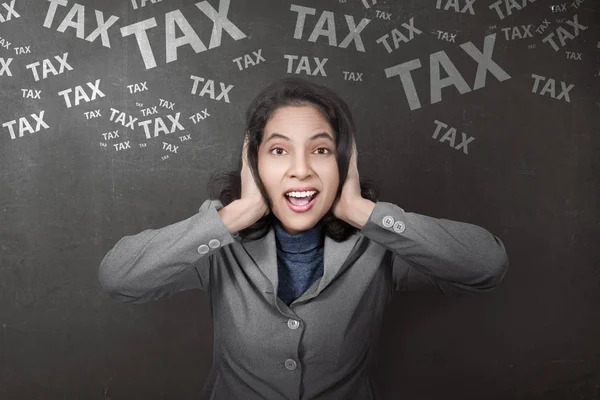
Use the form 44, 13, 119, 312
258, 106, 339, 235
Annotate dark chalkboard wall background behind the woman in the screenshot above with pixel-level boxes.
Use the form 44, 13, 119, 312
0, 0, 600, 400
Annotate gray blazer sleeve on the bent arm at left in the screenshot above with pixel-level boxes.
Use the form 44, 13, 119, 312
98, 200, 237, 303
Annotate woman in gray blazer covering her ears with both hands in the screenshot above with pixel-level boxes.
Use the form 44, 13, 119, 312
99, 78, 508, 400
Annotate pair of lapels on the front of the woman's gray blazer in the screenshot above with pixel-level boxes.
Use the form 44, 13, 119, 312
241, 227, 360, 302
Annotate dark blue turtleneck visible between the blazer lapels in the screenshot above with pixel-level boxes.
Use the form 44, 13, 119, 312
273, 219, 325, 306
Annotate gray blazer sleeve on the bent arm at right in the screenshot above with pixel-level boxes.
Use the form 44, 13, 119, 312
361, 202, 508, 294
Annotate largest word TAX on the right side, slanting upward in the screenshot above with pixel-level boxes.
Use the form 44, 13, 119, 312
385, 33, 510, 110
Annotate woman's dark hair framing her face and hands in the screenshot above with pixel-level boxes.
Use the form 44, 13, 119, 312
208, 77, 379, 242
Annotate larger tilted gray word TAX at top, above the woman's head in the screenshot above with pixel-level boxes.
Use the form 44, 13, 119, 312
290, 4, 371, 52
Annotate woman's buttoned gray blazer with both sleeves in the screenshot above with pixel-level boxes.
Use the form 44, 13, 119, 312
98, 200, 508, 400
